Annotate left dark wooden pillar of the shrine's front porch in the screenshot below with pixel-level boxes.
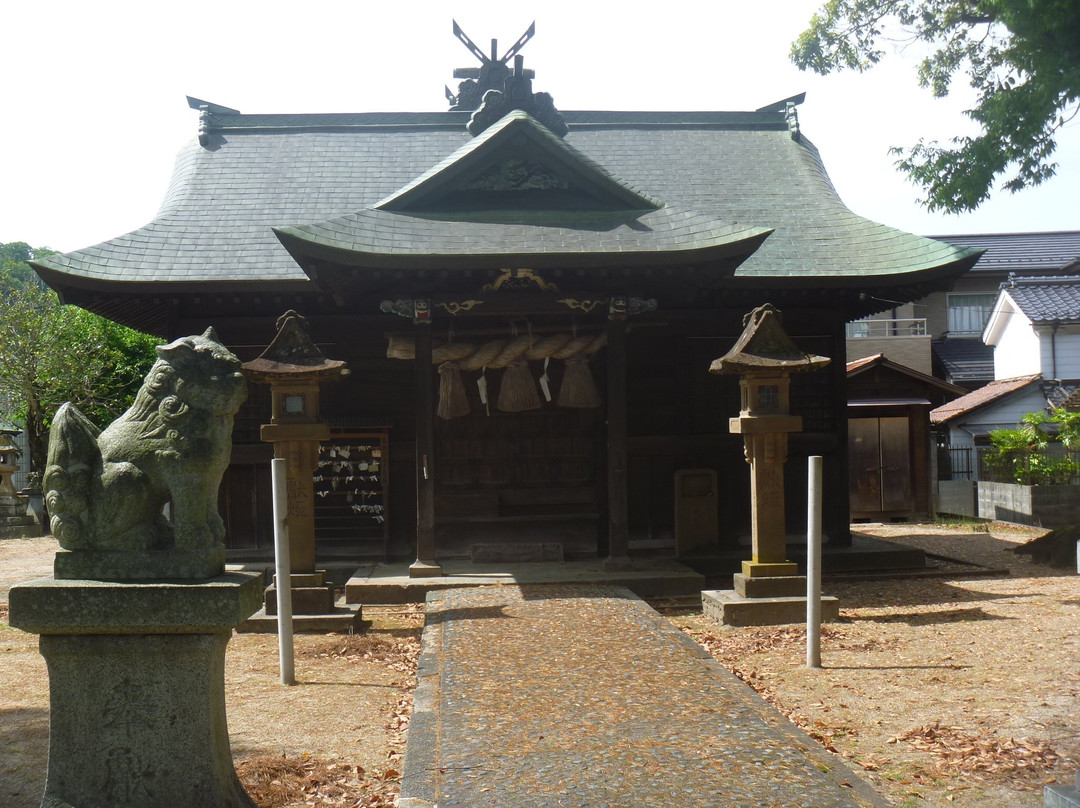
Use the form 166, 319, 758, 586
408, 318, 443, 578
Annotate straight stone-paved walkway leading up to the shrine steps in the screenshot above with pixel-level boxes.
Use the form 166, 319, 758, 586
401, 584, 889, 808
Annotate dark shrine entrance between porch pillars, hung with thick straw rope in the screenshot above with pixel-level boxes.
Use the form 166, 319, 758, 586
388, 319, 617, 562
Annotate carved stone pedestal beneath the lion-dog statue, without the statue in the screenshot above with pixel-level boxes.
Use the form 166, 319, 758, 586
10, 573, 261, 808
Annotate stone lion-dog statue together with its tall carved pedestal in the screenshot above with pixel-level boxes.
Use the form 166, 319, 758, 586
10, 329, 261, 808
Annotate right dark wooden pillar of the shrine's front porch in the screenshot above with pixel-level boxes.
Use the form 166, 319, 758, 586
604, 315, 633, 570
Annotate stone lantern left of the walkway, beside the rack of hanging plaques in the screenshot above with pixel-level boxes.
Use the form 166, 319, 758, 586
243, 310, 349, 615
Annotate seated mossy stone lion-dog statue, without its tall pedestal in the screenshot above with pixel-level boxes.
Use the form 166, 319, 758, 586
43, 328, 247, 554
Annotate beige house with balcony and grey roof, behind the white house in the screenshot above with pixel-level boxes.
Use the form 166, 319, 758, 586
848, 230, 1080, 390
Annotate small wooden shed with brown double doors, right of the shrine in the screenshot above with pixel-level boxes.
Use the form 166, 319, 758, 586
848, 354, 964, 522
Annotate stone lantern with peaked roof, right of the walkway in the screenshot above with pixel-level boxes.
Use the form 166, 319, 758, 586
710, 304, 835, 624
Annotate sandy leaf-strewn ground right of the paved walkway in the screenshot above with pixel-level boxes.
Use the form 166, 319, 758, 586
666, 525, 1080, 808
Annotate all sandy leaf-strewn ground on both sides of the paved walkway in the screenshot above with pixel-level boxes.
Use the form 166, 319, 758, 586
6, 525, 1080, 808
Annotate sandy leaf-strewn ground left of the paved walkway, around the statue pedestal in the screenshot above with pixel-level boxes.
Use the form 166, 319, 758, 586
0, 537, 422, 808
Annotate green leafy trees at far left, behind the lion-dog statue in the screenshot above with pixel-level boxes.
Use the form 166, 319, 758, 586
0, 242, 160, 472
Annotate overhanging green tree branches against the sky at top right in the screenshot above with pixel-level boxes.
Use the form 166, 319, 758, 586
791, 0, 1080, 213
